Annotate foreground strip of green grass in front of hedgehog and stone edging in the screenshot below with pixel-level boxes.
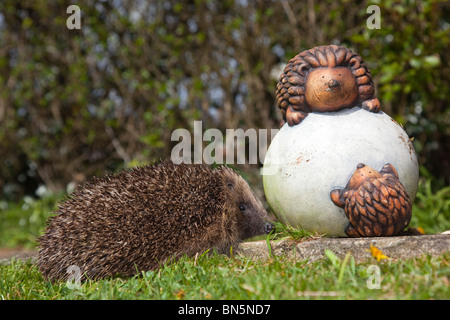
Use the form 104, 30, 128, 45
0, 253, 450, 300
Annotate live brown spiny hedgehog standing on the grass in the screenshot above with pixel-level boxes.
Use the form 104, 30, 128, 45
37, 161, 273, 281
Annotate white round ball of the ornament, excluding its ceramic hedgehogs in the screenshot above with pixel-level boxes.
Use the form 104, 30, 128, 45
263, 107, 419, 237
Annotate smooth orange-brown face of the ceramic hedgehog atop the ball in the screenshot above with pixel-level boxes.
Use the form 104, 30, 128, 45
305, 67, 358, 112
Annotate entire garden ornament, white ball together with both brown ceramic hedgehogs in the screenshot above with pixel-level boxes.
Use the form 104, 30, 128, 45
262, 45, 419, 237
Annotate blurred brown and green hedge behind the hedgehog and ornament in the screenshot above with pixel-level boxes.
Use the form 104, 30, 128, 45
0, 0, 450, 199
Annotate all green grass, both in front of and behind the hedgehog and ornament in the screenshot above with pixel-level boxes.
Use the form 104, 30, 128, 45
0, 174, 450, 299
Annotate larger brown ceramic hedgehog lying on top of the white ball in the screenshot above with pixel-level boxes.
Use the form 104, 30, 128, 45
276, 45, 380, 126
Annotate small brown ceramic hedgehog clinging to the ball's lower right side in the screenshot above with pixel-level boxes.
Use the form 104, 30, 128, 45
330, 163, 412, 237
